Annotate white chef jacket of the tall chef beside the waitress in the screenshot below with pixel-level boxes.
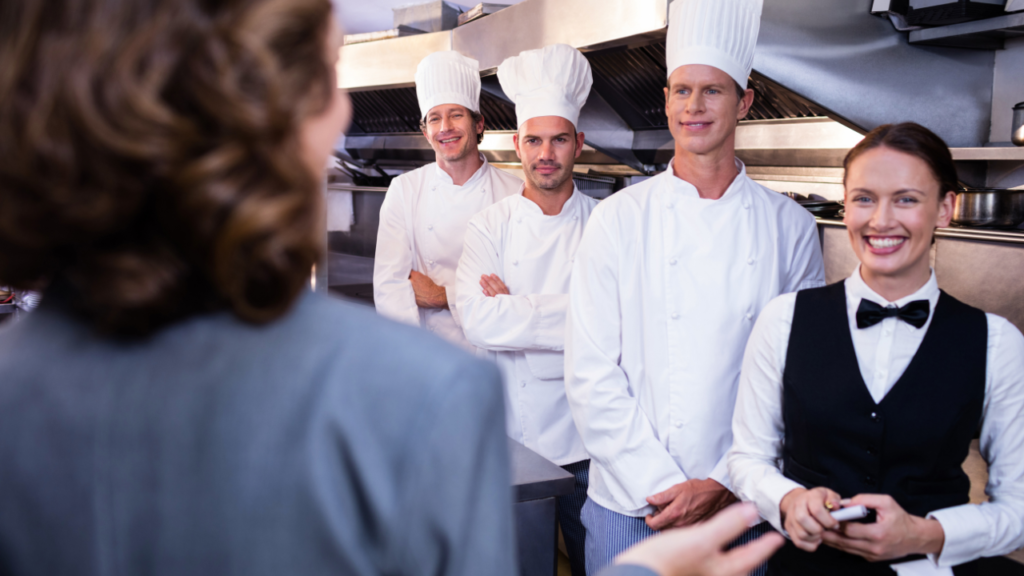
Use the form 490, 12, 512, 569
565, 160, 824, 517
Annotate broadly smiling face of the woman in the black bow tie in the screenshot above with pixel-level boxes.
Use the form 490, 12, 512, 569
844, 147, 955, 282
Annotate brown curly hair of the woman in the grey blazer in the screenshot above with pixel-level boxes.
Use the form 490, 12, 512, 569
0, 0, 336, 336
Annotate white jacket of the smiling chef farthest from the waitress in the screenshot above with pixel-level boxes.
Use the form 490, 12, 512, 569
374, 155, 522, 351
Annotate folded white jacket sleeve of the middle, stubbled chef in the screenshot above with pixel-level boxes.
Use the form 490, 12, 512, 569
456, 214, 568, 352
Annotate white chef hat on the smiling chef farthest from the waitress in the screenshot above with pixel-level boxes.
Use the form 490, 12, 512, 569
416, 50, 480, 118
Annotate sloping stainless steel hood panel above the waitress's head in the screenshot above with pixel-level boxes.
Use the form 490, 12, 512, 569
754, 0, 994, 147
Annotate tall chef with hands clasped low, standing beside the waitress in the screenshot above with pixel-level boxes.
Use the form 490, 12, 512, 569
565, 0, 824, 573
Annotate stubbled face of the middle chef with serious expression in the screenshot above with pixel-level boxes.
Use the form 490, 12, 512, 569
512, 116, 584, 190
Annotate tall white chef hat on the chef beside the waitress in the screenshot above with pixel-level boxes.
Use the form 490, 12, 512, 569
666, 0, 763, 88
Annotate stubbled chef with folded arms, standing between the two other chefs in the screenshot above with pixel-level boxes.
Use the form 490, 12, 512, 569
457, 44, 597, 576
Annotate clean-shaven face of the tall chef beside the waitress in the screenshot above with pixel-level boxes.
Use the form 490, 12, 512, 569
665, 64, 754, 155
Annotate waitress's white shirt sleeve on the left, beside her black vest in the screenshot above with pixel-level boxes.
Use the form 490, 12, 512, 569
726, 293, 803, 534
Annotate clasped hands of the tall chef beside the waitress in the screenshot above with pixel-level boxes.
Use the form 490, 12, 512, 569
644, 479, 736, 530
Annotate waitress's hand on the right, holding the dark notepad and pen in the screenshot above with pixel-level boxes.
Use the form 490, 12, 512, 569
822, 494, 945, 562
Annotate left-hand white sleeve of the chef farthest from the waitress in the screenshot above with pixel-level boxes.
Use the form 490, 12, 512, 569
374, 178, 420, 326
